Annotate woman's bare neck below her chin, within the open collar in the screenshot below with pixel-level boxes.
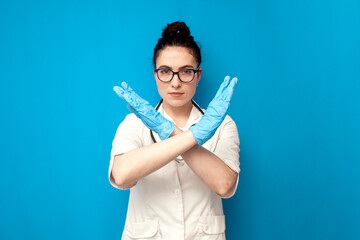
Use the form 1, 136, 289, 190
163, 101, 192, 127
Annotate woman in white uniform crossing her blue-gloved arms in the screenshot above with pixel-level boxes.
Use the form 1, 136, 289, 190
109, 22, 240, 240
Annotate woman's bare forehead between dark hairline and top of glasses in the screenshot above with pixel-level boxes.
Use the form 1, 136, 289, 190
156, 46, 196, 69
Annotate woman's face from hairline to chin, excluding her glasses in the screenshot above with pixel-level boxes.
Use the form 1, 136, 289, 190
154, 46, 202, 107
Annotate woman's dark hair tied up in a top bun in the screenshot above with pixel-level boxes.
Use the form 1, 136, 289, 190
153, 22, 201, 67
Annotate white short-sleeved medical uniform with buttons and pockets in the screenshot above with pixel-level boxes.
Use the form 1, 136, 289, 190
109, 106, 240, 240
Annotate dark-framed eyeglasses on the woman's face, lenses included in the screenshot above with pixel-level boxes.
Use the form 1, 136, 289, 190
155, 68, 199, 83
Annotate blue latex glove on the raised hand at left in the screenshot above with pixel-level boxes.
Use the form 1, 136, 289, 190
114, 82, 174, 140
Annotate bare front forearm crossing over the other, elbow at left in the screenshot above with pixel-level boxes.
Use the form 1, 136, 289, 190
111, 130, 197, 188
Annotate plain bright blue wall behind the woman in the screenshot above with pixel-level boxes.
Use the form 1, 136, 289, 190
0, 0, 360, 240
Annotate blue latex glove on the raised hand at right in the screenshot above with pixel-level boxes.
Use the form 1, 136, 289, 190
190, 76, 238, 145
